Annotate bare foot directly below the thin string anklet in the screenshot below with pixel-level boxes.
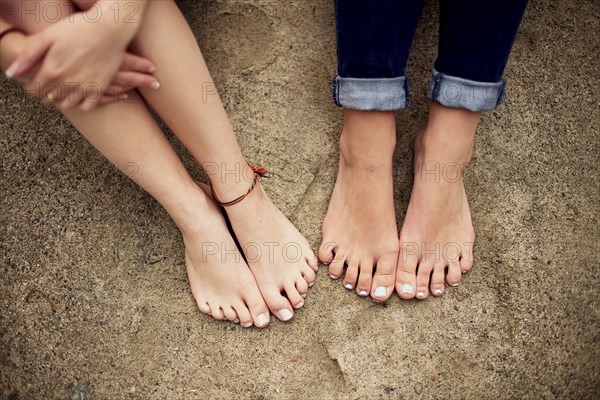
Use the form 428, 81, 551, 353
225, 183, 318, 321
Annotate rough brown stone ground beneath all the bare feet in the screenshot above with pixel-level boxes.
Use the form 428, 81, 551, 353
0, 0, 600, 400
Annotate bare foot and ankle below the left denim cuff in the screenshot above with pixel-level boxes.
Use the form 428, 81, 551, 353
319, 110, 398, 301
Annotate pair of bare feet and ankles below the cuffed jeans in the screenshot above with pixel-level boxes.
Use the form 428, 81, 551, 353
319, 103, 480, 301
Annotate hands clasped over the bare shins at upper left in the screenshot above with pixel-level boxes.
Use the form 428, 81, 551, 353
7, 13, 160, 110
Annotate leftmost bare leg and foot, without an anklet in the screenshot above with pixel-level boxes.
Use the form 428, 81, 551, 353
5, 3, 269, 327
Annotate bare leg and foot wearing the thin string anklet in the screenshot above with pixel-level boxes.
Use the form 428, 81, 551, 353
127, 1, 317, 320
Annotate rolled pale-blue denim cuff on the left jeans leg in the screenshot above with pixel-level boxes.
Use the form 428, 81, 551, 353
333, 75, 410, 111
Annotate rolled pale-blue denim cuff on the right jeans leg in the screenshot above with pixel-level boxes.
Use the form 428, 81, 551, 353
428, 68, 506, 111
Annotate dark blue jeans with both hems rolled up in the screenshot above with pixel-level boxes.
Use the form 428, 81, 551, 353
333, 0, 527, 111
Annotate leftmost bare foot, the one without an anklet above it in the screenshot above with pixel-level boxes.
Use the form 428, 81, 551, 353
180, 185, 269, 328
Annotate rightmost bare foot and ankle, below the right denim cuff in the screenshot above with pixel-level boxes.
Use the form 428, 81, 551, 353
396, 103, 480, 299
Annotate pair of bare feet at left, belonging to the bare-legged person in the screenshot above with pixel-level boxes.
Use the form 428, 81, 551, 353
180, 180, 318, 328
